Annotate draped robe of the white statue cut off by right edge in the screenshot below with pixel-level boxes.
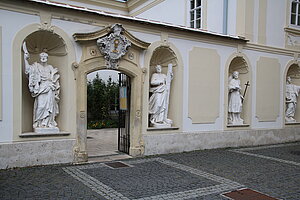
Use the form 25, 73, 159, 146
285, 84, 300, 117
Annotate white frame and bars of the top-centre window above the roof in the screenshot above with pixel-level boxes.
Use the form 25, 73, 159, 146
189, 0, 203, 28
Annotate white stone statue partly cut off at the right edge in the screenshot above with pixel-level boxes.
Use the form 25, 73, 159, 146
285, 76, 300, 123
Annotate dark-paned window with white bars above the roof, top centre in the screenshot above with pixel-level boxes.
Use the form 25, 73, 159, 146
190, 0, 202, 28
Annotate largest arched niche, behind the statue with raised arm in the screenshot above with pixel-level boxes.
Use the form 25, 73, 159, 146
21, 30, 71, 133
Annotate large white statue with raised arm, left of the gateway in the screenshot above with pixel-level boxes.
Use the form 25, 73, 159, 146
23, 42, 60, 133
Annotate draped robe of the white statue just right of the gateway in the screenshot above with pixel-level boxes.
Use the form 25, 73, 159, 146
149, 73, 168, 123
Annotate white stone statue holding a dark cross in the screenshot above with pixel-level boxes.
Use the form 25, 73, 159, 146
228, 71, 244, 125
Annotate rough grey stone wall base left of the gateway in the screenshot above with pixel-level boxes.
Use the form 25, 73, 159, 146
0, 139, 76, 169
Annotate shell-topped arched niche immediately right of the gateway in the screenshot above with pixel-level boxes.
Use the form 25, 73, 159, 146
148, 46, 182, 127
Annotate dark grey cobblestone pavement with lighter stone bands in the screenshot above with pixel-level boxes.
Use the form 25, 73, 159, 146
0, 142, 300, 200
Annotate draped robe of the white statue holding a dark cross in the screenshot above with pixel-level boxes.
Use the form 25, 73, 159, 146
228, 78, 242, 113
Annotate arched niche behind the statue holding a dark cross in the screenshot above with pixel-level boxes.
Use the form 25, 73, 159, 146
225, 56, 251, 127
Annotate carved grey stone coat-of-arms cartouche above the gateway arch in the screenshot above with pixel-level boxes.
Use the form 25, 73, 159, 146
97, 24, 131, 69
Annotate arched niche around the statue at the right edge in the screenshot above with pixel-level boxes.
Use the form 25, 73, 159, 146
284, 63, 300, 124
